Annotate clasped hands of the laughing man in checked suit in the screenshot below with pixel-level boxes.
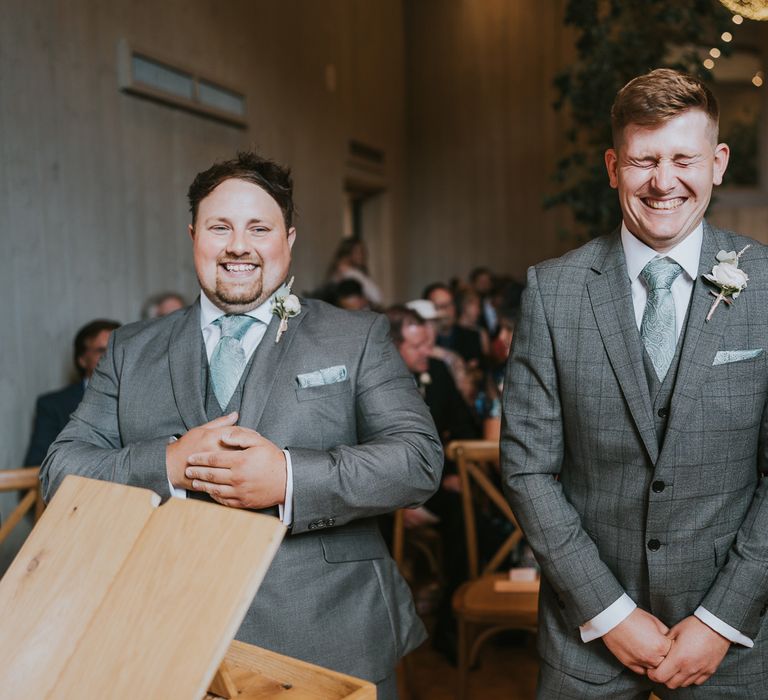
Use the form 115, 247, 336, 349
603, 608, 731, 689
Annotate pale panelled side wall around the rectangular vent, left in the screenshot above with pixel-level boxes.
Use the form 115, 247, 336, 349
0, 0, 405, 476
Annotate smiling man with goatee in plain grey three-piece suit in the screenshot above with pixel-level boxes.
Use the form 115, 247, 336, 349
41, 153, 442, 697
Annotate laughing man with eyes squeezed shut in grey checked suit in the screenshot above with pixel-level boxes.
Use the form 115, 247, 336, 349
501, 70, 768, 700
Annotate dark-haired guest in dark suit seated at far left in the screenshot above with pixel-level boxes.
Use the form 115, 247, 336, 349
24, 319, 120, 466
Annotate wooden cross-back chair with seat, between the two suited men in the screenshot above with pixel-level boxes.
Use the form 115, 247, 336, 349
446, 440, 538, 699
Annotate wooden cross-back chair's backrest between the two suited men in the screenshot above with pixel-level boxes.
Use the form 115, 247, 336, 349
446, 440, 523, 579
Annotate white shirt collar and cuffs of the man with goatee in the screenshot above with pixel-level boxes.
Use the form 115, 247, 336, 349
169, 290, 293, 525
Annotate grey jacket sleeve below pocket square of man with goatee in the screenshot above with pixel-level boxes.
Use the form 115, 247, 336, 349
288, 316, 443, 533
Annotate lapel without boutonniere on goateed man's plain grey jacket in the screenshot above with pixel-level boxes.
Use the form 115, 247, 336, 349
168, 299, 208, 430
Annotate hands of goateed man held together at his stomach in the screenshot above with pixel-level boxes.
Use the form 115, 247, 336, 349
165, 412, 287, 509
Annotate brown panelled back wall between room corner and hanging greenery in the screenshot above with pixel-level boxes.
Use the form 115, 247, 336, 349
406, 0, 572, 294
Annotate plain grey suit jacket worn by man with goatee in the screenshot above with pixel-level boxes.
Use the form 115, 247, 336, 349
41, 301, 442, 681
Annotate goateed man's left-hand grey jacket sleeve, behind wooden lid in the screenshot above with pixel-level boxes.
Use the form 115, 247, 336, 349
40, 333, 170, 501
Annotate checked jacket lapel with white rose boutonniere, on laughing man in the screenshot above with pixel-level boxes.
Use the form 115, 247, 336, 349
662, 221, 733, 457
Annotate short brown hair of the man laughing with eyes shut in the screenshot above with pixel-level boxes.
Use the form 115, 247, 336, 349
611, 68, 720, 146
